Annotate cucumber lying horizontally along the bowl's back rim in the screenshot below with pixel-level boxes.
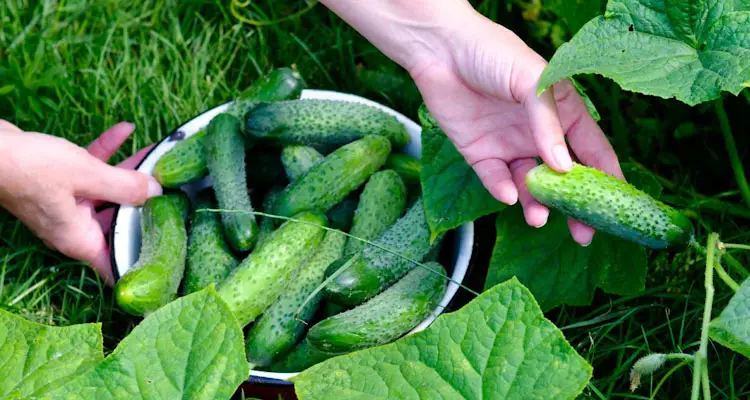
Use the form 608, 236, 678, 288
245, 100, 409, 153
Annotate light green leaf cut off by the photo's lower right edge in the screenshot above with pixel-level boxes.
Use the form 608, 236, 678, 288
708, 279, 750, 358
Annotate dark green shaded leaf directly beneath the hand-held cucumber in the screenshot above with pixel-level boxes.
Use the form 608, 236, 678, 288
485, 206, 647, 310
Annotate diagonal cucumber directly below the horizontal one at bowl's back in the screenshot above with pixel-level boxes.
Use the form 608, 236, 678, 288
273, 136, 391, 217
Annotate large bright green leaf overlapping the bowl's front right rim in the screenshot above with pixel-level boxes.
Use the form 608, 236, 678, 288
293, 279, 592, 400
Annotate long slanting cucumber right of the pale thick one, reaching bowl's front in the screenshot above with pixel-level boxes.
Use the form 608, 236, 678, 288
245, 232, 346, 366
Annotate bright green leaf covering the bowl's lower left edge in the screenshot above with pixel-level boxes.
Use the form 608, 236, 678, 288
43, 288, 250, 400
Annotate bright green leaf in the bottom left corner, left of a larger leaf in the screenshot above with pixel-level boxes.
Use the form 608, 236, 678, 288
0, 310, 104, 399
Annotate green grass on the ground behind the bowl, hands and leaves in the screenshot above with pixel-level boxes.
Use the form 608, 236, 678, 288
0, 0, 750, 399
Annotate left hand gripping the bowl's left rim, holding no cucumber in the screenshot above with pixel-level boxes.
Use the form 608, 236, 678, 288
0, 120, 162, 285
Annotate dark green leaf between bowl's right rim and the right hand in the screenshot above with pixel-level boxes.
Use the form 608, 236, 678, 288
420, 122, 505, 240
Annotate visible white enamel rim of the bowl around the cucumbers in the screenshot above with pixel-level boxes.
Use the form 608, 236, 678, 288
110, 90, 474, 385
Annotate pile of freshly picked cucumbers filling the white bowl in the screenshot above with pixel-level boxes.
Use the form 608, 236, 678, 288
115, 68, 448, 372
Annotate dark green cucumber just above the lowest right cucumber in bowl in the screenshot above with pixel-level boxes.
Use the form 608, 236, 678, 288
325, 199, 442, 306
